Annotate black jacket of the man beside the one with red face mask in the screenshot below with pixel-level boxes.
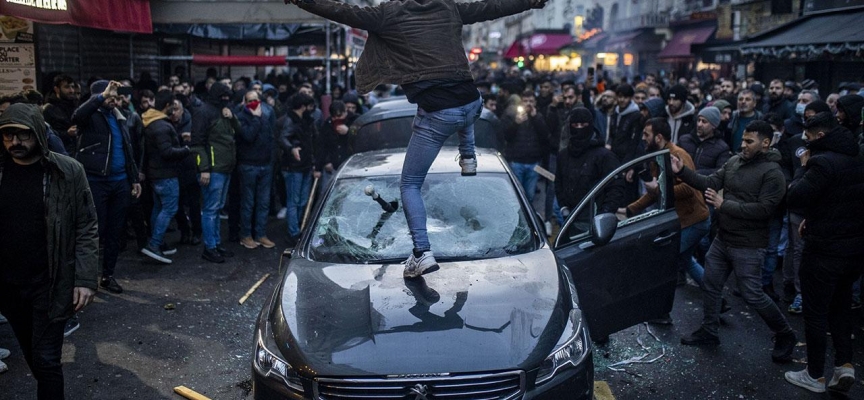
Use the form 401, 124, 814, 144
279, 111, 316, 172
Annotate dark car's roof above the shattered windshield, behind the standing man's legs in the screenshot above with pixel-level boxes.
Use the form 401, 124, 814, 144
339, 146, 506, 178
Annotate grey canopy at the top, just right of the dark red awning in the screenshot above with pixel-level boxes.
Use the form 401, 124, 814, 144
148, 0, 325, 24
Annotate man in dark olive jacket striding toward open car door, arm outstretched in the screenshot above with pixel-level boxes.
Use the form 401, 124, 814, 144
672, 121, 796, 362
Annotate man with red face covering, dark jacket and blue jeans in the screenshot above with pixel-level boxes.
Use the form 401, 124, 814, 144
237, 91, 276, 249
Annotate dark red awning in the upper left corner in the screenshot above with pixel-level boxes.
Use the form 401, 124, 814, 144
0, 0, 153, 33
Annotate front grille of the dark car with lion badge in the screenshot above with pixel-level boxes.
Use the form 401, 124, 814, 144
314, 371, 525, 400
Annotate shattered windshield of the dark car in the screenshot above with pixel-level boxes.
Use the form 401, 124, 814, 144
310, 173, 539, 264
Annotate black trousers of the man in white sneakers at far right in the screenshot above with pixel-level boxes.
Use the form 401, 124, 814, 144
798, 250, 861, 379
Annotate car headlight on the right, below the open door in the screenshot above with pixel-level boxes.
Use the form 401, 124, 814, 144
536, 309, 590, 385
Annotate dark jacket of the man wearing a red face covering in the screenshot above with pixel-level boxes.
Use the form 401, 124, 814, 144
235, 103, 276, 166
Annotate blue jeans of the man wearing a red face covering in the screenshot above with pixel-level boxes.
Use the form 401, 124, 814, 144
237, 165, 273, 239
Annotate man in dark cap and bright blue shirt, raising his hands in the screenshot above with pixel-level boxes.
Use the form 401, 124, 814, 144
72, 80, 141, 293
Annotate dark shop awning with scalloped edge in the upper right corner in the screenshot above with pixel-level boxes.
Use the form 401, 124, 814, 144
741, 8, 864, 58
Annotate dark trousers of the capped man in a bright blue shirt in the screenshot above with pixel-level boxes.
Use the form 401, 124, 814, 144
89, 179, 132, 277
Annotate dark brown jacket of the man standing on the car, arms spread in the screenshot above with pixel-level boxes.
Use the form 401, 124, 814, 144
299, 0, 531, 93
